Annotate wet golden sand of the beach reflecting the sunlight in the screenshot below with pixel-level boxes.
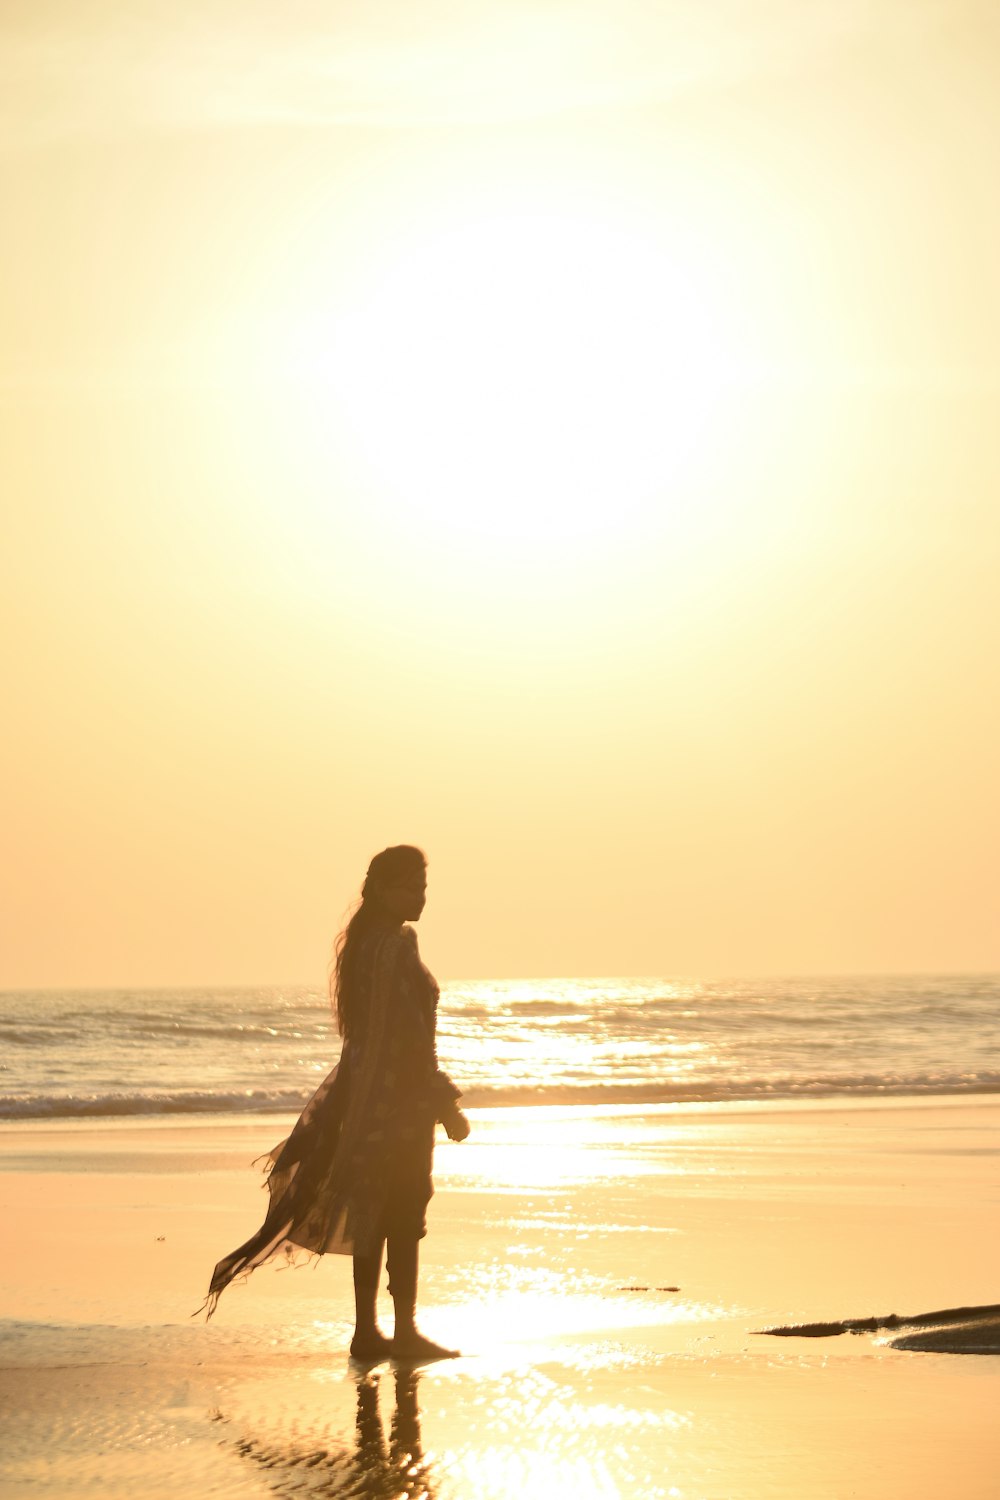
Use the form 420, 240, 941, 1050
0, 1098, 1000, 1500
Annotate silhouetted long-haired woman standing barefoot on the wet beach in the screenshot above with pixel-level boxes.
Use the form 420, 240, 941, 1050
205, 845, 469, 1359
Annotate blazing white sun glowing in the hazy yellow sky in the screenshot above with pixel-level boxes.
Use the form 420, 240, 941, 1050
280, 203, 742, 570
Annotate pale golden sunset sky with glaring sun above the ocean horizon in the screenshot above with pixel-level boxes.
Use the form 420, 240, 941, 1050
0, 0, 1000, 987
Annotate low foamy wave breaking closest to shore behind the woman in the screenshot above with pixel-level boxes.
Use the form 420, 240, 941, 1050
0, 1073, 1000, 1121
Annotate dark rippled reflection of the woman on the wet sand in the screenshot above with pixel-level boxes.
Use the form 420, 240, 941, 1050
216, 1367, 436, 1500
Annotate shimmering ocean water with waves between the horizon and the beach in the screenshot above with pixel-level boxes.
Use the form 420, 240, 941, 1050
0, 975, 1000, 1121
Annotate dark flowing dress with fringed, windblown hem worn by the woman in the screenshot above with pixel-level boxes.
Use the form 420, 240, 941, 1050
205, 927, 462, 1317
